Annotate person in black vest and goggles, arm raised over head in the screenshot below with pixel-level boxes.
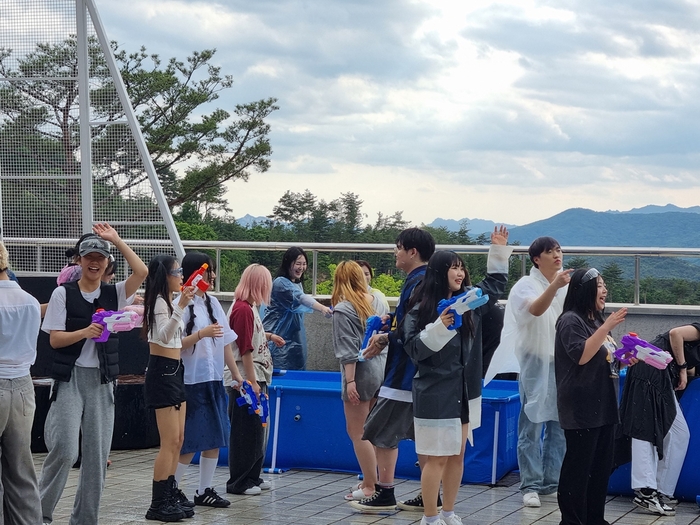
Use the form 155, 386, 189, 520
39, 223, 148, 523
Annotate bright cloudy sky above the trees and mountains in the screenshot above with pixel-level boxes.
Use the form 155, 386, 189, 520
96, 0, 700, 224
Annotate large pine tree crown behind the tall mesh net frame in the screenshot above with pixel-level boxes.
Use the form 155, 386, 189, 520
0, 37, 279, 223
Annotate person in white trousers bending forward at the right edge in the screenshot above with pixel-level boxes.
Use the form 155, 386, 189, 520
620, 323, 700, 516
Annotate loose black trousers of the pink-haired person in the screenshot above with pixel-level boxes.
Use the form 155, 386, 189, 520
226, 383, 270, 494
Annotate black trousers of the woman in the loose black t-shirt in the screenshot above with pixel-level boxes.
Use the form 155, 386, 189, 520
557, 425, 615, 525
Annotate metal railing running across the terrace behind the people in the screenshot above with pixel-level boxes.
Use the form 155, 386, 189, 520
4, 237, 700, 305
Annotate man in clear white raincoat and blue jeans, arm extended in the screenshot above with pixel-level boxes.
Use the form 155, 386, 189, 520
485, 237, 573, 507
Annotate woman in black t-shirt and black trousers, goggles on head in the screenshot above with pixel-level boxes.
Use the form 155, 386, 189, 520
554, 268, 637, 525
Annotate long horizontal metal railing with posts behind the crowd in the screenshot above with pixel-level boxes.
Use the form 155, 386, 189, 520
5, 237, 700, 304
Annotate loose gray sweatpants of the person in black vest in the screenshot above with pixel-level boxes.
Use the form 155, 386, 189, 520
39, 366, 114, 525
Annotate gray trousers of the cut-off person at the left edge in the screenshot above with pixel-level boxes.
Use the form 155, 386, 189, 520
0, 375, 41, 525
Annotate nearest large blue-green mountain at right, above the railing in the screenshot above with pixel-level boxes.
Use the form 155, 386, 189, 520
510, 208, 700, 248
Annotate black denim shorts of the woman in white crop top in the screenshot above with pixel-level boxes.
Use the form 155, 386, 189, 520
144, 354, 185, 409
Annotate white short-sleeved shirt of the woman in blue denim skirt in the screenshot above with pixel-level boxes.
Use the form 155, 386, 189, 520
180, 295, 237, 385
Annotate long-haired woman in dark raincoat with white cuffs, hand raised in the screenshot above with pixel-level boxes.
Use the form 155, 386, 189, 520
400, 231, 513, 525
